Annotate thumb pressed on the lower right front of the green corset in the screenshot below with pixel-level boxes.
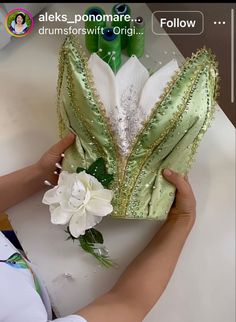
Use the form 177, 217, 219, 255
163, 169, 191, 196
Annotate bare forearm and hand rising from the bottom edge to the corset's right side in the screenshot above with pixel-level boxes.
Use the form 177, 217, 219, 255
78, 170, 196, 322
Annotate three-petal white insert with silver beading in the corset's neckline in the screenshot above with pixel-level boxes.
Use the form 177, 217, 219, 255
88, 54, 178, 155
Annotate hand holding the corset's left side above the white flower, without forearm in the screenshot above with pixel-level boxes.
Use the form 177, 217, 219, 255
37, 133, 75, 185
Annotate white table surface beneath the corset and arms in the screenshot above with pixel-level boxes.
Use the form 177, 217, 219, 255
0, 3, 235, 322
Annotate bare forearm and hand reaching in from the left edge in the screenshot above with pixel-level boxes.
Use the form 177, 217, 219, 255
0, 133, 74, 213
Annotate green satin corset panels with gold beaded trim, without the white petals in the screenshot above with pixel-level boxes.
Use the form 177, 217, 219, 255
58, 36, 218, 219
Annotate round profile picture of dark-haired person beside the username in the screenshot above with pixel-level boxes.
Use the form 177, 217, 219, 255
5, 8, 34, 37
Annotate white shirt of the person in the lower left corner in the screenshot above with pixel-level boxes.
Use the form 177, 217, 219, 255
0, 232, 86, 322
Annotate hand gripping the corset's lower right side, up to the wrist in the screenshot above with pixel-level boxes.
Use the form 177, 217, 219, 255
163, 169, 196, 221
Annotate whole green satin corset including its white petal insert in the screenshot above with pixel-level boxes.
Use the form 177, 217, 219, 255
58, 36, 218, 219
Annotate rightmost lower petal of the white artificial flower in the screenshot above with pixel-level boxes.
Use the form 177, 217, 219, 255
85, 199, 113, 217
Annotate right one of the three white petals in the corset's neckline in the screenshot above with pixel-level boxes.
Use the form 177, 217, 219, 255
139, 59, 178, 118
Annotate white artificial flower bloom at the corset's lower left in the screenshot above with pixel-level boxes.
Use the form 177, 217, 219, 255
43, 171, 113, 238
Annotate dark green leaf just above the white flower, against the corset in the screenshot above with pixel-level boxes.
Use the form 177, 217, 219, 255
86, 158, 114, 188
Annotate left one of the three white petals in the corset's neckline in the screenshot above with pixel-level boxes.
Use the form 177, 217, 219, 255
88, 54, 118, 121
